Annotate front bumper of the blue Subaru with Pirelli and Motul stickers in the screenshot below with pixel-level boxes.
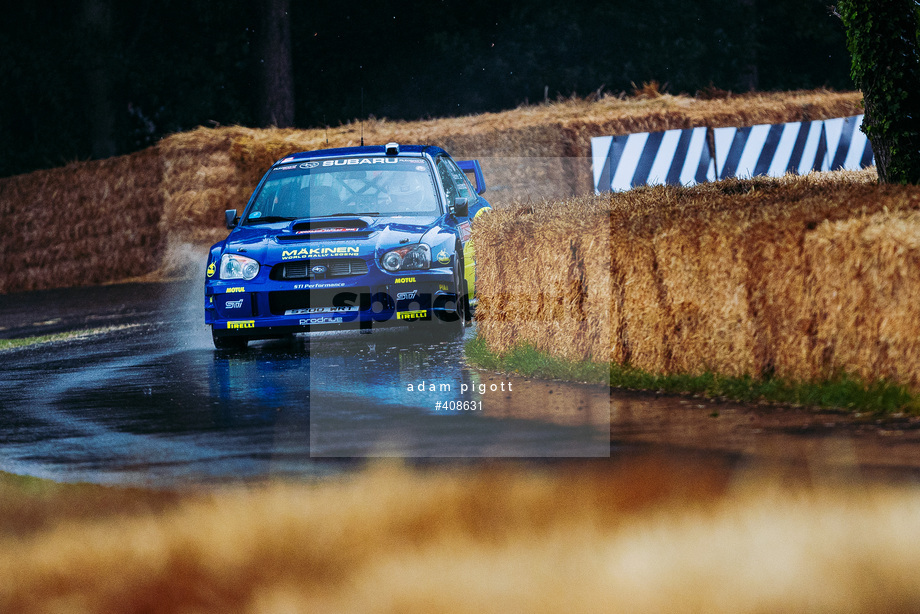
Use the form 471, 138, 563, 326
204, 267, 460, 339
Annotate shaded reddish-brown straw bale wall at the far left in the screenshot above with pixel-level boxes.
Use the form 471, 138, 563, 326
0, 150, 163, 293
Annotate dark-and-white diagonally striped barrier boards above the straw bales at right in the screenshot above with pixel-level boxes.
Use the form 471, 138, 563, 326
591, 115, 873, 193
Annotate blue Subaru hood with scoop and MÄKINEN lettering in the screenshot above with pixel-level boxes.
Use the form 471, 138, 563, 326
224, 216, 443, 264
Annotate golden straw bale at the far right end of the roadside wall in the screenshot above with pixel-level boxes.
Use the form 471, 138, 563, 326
805, 210, 920, 387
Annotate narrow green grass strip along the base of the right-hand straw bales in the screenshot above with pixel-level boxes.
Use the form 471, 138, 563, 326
466, 337, 920, 414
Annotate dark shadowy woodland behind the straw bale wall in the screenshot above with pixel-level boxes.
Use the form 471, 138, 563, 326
0, 0, 852, 176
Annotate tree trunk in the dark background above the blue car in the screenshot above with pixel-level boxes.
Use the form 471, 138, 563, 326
256, 0, 294, 128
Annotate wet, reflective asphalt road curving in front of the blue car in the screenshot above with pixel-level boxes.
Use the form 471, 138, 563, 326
7, 283, 920, 486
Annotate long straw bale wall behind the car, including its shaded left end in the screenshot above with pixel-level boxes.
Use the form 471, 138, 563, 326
0, 91, 860, 296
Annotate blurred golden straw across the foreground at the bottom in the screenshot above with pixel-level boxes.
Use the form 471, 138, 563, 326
0, 459, 920, 613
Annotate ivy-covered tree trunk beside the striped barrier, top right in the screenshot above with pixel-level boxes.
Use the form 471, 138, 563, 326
836, 0, 920, 183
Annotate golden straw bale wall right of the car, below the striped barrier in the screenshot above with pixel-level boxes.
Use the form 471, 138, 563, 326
474, 172, 920, 387
